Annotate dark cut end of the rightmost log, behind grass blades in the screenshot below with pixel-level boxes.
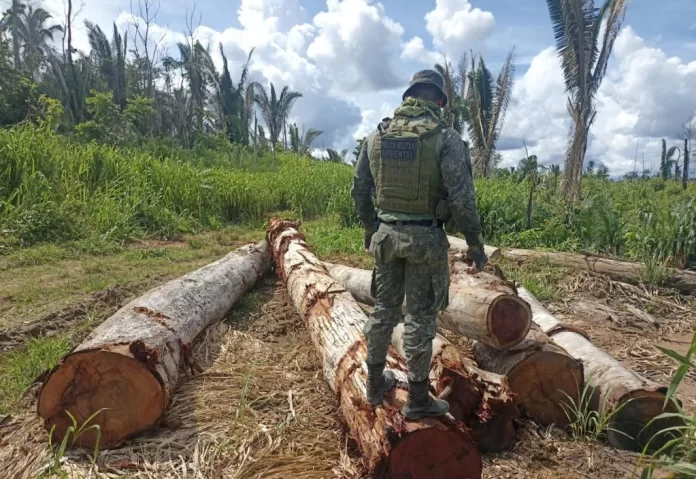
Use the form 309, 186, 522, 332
607, 390, 684, 452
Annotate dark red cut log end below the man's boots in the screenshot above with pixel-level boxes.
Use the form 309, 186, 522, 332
388, 428, 482, 479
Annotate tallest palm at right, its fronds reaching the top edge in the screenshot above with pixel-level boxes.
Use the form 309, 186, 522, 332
546, 0, 629, 203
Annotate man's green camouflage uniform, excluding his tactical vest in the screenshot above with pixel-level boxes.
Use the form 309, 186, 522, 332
351, 71, 482, 418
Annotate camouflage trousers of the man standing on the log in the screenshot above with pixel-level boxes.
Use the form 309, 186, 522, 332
363, 224, 449, 382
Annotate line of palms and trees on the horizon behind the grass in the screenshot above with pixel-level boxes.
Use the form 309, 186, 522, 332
0, 0, 694, 196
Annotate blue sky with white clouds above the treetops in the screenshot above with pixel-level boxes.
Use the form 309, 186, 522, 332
16, 0, 696, 176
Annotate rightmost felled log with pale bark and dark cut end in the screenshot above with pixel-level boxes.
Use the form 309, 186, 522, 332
519, 287, 683, 451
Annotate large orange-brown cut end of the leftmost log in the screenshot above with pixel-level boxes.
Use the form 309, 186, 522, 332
38, 350, 165, 448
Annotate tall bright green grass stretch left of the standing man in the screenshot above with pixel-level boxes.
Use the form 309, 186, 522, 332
0, 126, 352, 246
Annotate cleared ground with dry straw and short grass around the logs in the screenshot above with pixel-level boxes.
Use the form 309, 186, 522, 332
0, 220, 696, 479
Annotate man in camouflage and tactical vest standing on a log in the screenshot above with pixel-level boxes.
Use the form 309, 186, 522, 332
351, 70, 488, 419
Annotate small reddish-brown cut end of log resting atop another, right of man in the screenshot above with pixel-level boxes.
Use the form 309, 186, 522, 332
488, 295, 532, 349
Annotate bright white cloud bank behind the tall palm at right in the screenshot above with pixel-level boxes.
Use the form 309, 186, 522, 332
501, 27, 696, 175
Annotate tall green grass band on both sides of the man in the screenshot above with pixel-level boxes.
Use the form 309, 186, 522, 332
0, 125, 696, 271
